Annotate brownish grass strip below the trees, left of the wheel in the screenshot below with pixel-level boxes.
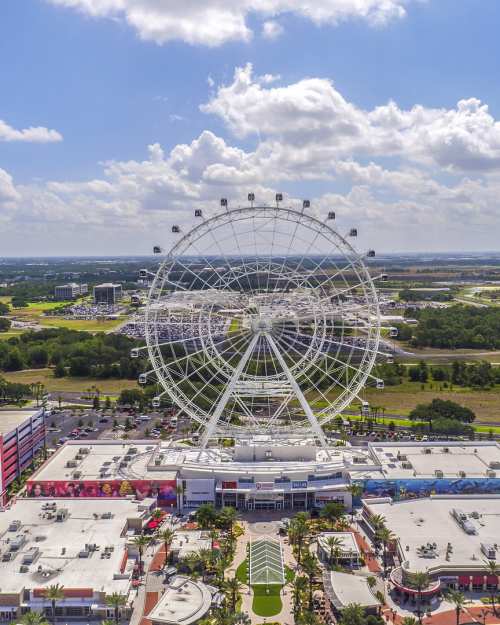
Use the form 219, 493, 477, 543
2, 369, 137, 394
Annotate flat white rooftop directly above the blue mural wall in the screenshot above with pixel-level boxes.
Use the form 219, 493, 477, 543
369, 441, 500, 479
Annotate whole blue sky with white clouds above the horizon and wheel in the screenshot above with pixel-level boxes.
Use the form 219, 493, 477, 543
0, 0, 500, 255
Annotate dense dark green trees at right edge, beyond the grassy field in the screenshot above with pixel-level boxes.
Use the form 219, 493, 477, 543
401, 305, 500, 349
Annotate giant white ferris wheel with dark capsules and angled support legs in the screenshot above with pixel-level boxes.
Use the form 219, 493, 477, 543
132, 194, 387, 447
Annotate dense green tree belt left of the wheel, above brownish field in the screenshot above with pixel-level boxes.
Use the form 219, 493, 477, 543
0, 328, 145, 379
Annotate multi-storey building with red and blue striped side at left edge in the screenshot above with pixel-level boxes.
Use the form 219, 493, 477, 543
0, 409, 45, 504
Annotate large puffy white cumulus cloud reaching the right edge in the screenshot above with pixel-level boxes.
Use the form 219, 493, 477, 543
201, 63, 500, 171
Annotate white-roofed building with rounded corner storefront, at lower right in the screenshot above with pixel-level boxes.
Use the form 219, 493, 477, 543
363, 495, 500, 595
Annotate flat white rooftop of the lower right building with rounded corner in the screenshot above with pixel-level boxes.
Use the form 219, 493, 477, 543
365, 495, 500, 571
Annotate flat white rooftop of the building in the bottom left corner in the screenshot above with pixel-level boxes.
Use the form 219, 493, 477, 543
0, 498, 145, 595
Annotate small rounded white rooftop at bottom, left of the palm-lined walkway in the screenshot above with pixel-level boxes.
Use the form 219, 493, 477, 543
148, 575, 212, 625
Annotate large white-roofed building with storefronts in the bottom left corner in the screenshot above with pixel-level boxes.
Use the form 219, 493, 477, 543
0, 498, 155, 622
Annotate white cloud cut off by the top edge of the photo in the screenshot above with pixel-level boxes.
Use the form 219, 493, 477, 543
48, 0, 417, 46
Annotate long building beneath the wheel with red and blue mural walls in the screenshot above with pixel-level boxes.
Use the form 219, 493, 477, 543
23, 437, 500, 510
